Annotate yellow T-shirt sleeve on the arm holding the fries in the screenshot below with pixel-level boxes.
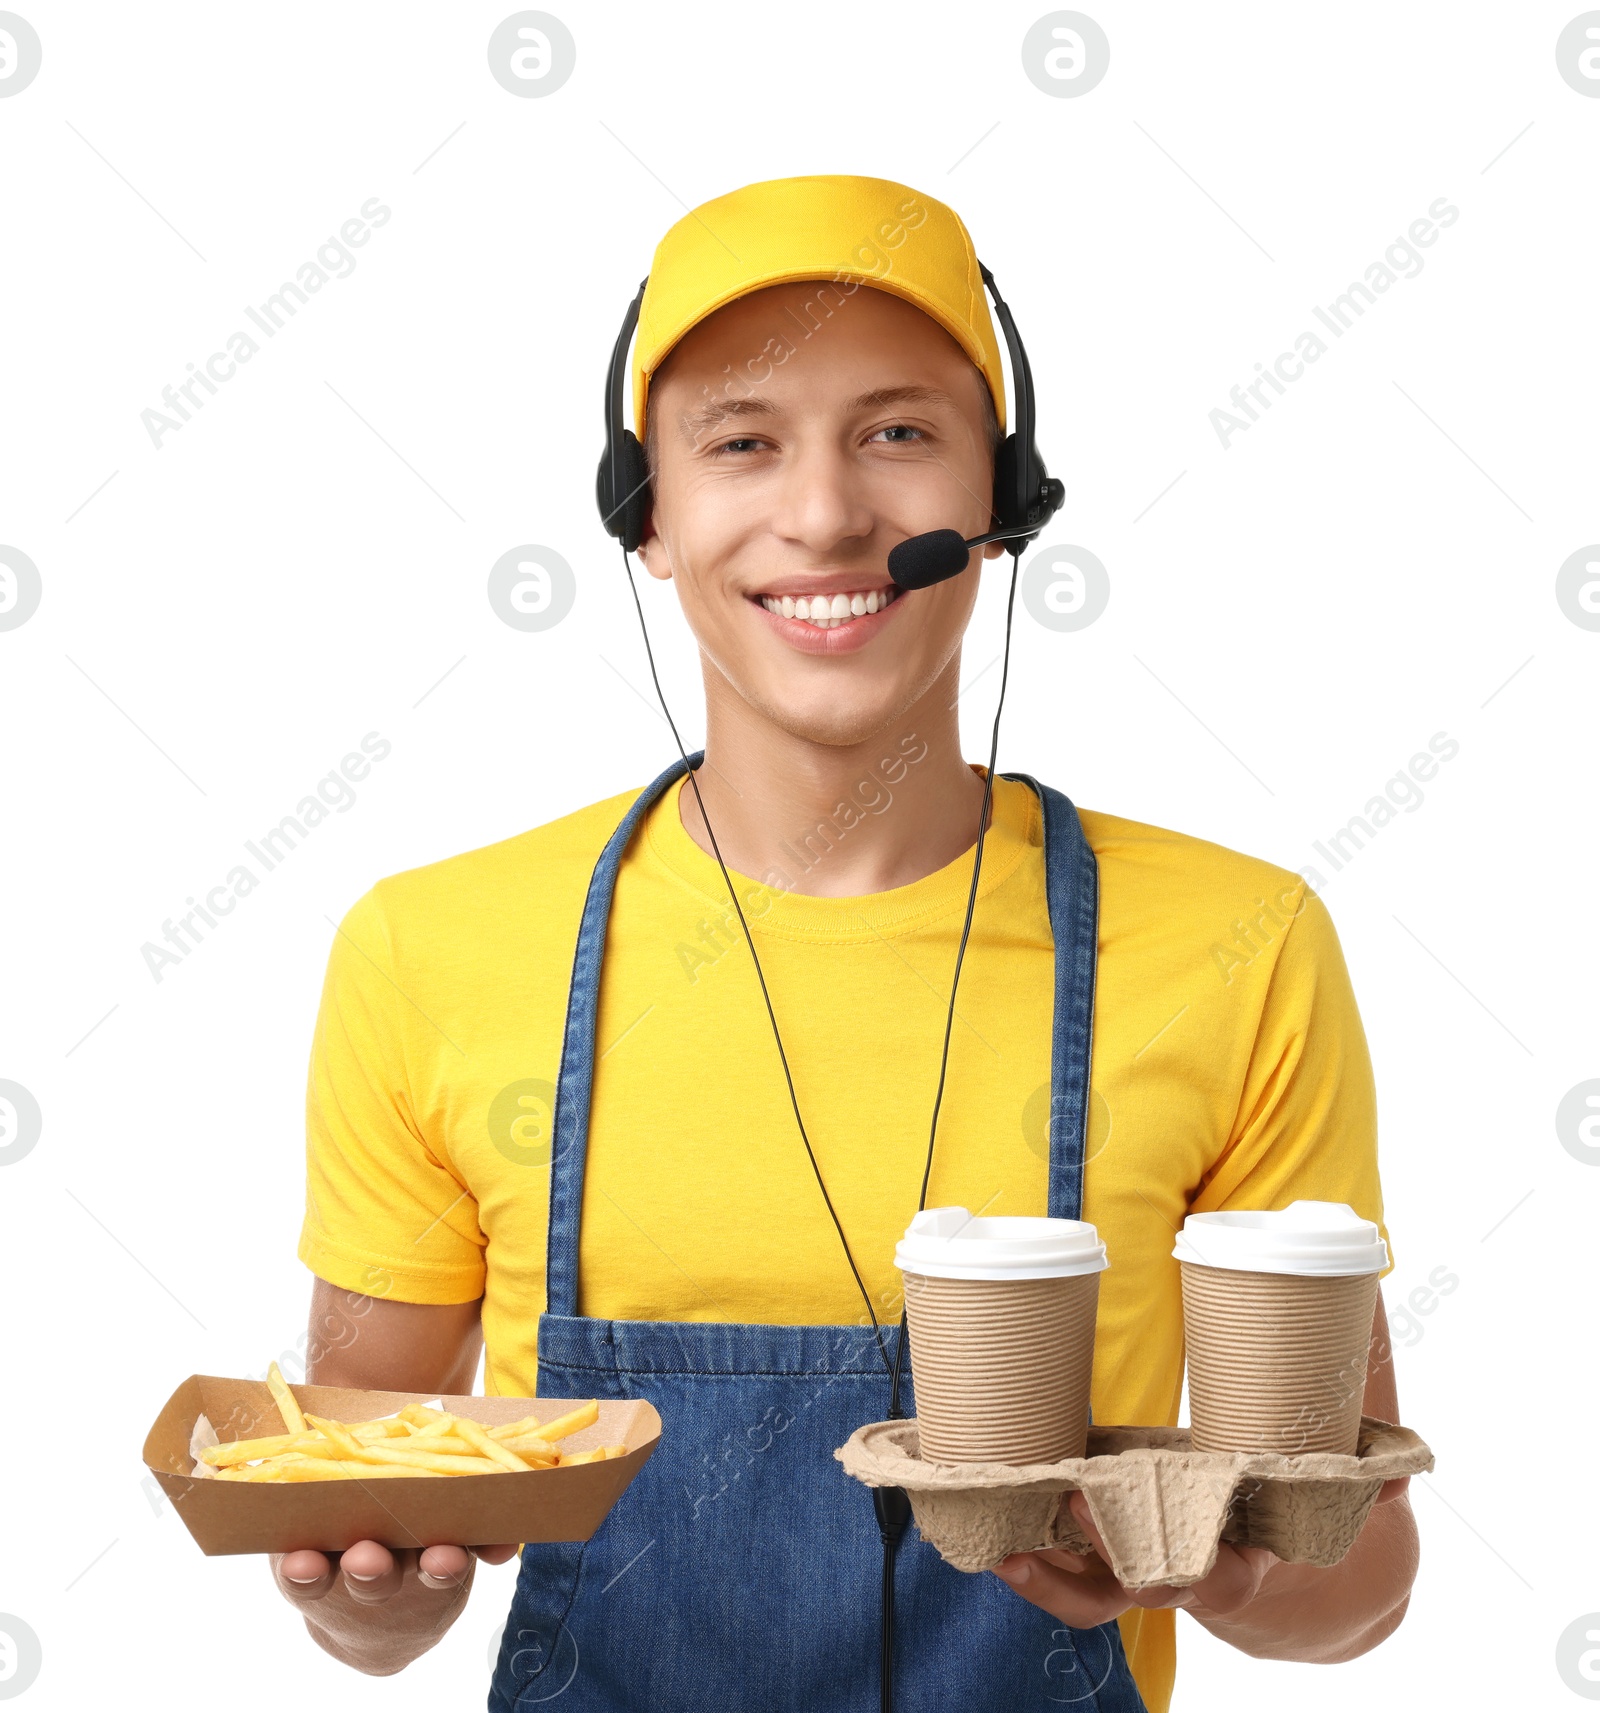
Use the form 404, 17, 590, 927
298, 887, 483, 1304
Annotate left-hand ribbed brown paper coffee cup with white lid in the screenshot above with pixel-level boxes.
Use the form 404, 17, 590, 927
894, 1208, 1107, 1463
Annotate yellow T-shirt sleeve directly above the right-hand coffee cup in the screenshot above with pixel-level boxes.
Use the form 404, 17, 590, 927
1191, 887, 1394, 1273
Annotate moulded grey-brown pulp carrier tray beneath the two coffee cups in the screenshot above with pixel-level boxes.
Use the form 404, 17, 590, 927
834, 1415, 1434, 1588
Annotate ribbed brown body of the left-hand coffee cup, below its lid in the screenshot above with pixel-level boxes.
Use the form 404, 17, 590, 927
904, 1273, 1100, 1463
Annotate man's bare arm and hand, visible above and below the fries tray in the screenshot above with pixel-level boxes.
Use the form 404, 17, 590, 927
272, 1280, 517, 1675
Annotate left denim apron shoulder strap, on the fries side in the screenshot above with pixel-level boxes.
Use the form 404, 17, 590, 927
545, 750, 706, 1316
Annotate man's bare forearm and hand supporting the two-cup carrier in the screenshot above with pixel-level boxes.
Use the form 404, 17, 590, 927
995, 1290, 1418, 1663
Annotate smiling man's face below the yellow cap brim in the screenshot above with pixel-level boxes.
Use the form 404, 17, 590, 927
639, 281, 1004, 745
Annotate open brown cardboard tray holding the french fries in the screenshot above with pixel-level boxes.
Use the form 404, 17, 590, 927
144, 1374, 661, 1554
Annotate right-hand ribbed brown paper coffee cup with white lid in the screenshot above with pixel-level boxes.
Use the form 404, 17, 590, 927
1173, 1201, 1388, 1456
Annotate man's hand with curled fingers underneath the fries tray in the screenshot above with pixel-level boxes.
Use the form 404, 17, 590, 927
272, 1540, 517, 1677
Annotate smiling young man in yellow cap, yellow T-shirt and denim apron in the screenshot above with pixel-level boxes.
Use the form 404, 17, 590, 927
276, 178, 1417, 1713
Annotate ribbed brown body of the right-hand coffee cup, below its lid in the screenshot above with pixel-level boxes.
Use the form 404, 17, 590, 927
1185, 1261, 1377, 1456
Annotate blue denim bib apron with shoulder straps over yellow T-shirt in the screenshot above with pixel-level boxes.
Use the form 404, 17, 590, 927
488, 755, 1144, 1713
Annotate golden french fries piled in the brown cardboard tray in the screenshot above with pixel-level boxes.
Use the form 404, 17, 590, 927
200, 1362, 627, 1482
